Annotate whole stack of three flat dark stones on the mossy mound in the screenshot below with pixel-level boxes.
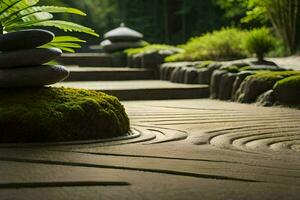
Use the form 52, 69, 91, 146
0, 29, 69, 88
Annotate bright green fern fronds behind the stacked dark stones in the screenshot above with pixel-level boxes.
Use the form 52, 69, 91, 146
0, 0, 98, 52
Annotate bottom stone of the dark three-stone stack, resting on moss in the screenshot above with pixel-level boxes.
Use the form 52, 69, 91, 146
0, 65, 69, 88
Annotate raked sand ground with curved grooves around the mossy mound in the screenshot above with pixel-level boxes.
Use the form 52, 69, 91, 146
0, 99, 300, 200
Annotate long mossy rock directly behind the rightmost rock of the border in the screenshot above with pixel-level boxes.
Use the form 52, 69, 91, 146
236, 71, 299, 103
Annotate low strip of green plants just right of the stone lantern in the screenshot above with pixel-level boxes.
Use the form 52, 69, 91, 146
124, 44, 182, 56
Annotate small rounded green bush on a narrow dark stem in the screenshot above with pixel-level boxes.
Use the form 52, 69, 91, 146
244, 28, 276, 63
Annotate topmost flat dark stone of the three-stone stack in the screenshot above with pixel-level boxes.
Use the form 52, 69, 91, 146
0, 29, 55, 51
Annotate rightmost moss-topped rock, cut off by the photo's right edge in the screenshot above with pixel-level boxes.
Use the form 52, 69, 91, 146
274, 75, 300, 106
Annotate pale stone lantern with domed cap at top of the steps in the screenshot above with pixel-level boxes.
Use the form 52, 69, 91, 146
100, 23, 144, 53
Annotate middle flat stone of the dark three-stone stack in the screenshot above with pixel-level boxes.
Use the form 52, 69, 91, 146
0, 48, 62, 68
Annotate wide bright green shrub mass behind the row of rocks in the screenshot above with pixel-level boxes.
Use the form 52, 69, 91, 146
165, 28, 247, 62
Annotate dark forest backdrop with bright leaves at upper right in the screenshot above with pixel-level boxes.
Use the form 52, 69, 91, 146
41, 0, 300, 53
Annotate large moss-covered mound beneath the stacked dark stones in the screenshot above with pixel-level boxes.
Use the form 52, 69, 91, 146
0, 88, 129, 143
